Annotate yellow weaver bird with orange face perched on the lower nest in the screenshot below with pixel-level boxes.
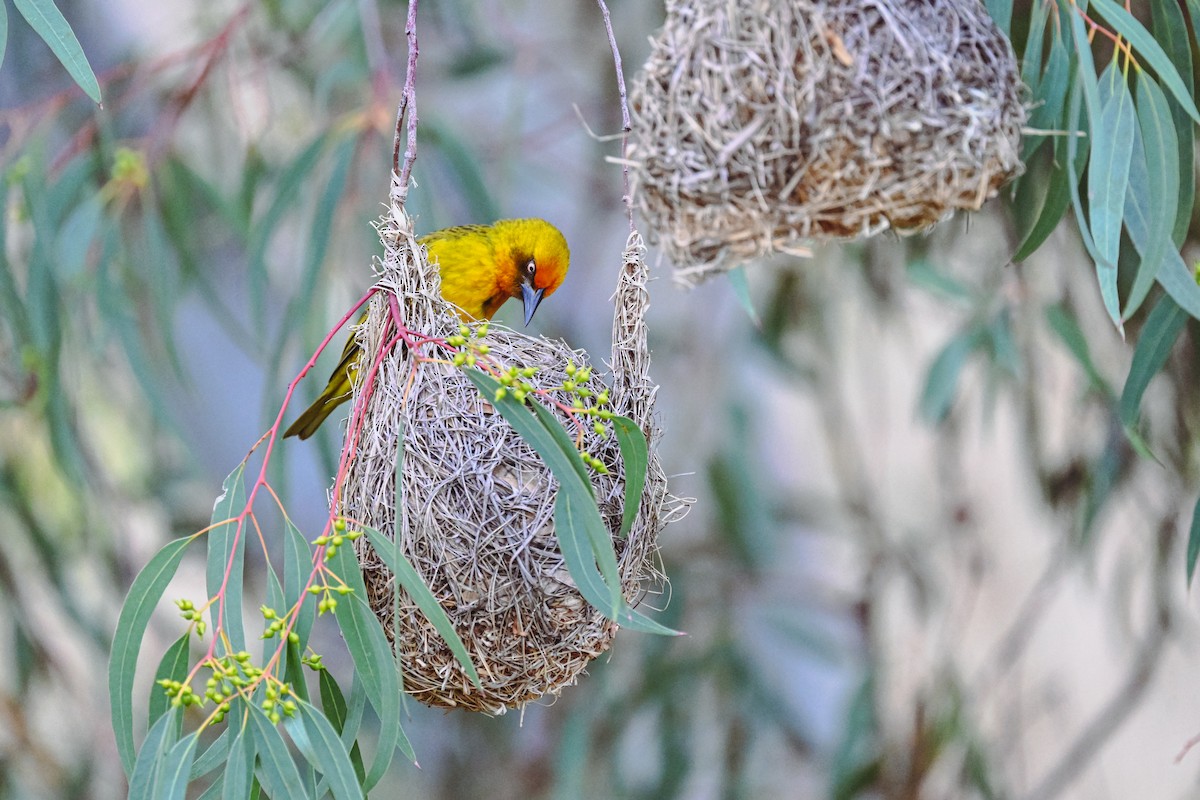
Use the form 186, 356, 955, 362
283, 219, 571, 439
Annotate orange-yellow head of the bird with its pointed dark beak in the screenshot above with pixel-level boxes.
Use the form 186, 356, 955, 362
493, 219, 571, 325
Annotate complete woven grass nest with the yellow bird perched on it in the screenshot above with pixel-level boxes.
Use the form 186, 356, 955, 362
342, 207, 686, 714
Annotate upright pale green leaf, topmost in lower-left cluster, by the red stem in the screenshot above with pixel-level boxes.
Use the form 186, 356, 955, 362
205, 462, 248, 652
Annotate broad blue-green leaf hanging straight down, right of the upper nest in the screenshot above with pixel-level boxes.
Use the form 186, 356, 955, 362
1087, 59, 1138, 329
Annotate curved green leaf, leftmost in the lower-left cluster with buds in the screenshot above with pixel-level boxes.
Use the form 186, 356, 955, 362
108, 536, 194, 775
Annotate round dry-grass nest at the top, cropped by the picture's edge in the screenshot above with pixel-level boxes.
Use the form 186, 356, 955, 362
630, 0, 1026, 283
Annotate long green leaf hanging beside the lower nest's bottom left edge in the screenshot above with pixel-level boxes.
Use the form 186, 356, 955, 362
328, 547, 416, 792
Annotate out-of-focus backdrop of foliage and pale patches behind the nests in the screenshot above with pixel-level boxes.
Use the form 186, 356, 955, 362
7, 0, 1200, 800
